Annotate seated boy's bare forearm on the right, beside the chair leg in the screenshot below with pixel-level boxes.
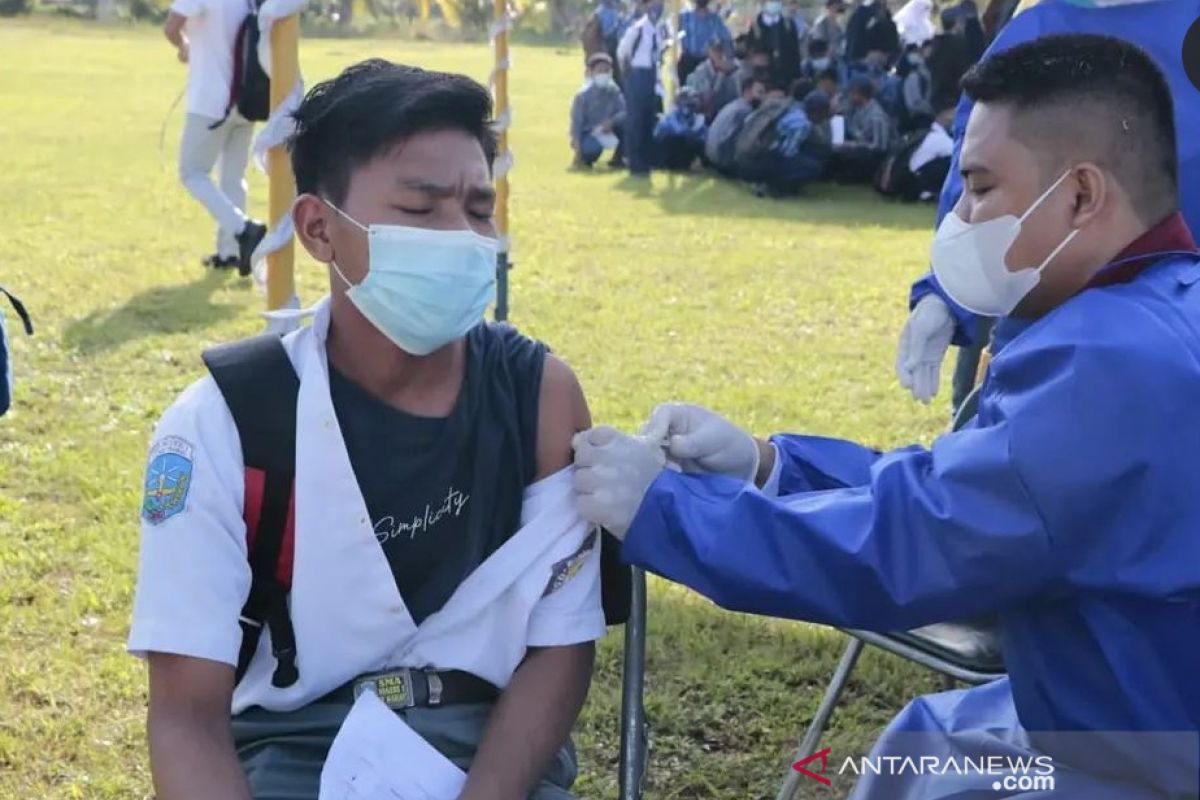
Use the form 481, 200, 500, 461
460, 642, 595, 800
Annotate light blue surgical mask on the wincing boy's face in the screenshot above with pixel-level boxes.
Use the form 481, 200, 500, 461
326, 200, 498, 356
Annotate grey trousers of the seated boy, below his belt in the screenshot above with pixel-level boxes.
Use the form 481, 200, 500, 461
233, 699, 578, 800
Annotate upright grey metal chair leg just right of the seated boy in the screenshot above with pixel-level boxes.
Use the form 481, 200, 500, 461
618, 569, 648, 800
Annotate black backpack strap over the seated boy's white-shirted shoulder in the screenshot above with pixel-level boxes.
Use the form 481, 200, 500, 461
203, 335, 300, 688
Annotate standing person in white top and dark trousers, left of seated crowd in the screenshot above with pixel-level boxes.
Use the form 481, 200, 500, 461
617, 0, 666, 178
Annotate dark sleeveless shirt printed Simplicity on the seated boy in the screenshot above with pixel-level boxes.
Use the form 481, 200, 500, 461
329, 324, 547, 625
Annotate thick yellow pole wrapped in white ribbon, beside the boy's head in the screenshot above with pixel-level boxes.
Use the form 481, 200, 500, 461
266, 14, 300, 311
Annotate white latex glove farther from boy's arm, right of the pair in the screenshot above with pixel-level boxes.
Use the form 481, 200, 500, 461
642, 403, 758, 483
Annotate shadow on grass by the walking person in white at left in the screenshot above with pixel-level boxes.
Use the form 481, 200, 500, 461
62, 271, 241, 354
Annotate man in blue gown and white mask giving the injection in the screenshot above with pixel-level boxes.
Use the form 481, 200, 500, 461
575, 35, 1200, 800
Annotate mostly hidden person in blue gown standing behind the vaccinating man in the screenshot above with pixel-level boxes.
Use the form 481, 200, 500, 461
895, 0, 1200, 409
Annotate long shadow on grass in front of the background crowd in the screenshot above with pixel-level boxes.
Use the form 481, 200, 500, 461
643, 169, 935, 235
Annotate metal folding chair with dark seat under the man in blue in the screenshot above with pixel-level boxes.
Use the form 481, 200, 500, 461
776, 387, 1004, 800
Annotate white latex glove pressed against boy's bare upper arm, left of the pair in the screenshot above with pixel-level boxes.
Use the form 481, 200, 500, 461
571, 427, 666, 539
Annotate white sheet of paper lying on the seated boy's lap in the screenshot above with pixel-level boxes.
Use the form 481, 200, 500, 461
318, 692, 467, 800
